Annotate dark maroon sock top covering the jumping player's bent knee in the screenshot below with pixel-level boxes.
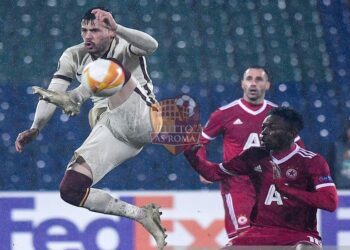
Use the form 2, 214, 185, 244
60, 170, 92, 206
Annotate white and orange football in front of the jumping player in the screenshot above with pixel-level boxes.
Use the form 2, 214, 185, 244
81, 59, 125, 97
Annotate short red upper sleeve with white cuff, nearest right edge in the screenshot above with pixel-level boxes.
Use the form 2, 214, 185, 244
308, 155, 335, 190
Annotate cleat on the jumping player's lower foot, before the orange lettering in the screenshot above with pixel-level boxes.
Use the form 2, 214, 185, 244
139, 203, 167, 250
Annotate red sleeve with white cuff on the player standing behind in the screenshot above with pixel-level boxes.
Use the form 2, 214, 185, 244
201, 109, 223, 144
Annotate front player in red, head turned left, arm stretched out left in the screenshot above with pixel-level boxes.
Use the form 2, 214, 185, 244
185, 107, 338, 249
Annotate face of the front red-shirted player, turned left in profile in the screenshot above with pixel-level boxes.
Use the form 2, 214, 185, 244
260, 115, 295, 151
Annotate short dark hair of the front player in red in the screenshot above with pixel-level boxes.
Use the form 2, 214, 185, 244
267, 107, 304, 133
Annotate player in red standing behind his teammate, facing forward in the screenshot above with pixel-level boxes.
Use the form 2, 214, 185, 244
200, 66, 276, 238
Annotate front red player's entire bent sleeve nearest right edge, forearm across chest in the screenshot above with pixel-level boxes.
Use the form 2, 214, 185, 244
275, 155, 338, 211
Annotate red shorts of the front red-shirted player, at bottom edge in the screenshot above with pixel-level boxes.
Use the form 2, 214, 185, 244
230, 226, 322, 247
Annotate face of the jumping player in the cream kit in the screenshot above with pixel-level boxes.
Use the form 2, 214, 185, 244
81, 19, 114, 58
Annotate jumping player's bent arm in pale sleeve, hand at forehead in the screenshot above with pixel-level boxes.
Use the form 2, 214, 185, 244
92, 9, 158, 56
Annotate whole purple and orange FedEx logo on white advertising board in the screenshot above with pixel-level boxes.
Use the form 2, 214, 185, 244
0, 193, 226, 250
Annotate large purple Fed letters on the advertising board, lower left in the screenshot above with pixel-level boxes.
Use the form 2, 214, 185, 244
0, 197, 134, 250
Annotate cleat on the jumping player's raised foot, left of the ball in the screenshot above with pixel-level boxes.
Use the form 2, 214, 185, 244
32, 86, 80, 116
